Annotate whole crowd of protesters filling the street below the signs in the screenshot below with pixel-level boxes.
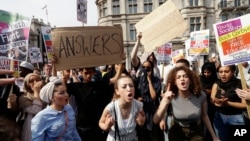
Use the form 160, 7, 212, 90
0, 34, 250, 141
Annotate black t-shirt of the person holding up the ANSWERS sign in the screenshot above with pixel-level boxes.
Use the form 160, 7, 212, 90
67, 81, 108, 128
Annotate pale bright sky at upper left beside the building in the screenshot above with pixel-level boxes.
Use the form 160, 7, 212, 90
0, 0, 97, 27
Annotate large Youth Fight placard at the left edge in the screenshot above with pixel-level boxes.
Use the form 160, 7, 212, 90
0, 10, 31, 61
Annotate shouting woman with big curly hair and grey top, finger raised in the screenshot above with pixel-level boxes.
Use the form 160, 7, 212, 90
153, 66, 218, 141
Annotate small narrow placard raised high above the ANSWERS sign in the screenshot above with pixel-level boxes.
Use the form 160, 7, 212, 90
77, 0, 87, 24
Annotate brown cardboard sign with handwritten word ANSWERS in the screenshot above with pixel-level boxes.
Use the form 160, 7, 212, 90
52, 26, 124, 70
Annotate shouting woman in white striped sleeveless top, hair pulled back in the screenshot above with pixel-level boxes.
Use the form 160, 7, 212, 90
99, 76, 145, 141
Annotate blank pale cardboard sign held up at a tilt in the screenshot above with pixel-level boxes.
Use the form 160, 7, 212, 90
135, 0, 188, 52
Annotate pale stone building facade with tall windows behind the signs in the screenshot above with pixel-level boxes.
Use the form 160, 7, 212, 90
96, 0, 250, 68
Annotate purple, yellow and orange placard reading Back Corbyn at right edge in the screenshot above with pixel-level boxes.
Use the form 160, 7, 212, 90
213, 14, 250, 65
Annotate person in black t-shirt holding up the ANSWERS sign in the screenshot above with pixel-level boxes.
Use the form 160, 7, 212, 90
67, 65, 121, 141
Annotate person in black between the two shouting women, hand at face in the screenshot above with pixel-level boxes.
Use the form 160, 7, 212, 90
135, 61, 164, 141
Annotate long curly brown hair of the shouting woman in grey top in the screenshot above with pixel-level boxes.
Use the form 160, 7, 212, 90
167, 66, 202, 97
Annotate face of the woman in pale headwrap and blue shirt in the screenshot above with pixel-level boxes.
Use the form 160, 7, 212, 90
52, 84, 69, 107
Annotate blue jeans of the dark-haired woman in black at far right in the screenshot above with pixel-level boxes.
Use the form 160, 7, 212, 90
214, 112, 245, 141
